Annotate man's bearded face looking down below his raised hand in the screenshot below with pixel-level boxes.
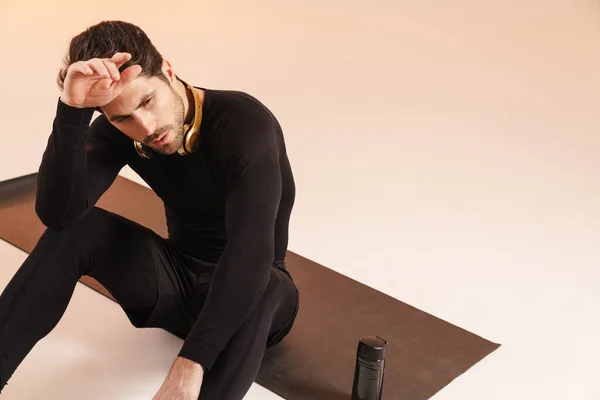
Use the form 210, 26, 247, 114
102, 73, 184, 154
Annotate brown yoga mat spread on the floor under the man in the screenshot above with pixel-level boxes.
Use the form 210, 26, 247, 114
0, 174, 499, 400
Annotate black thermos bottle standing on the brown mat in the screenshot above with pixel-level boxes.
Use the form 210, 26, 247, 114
352, 336, 387, 400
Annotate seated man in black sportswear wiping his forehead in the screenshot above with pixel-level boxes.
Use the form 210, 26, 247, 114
0, 21, 299, 400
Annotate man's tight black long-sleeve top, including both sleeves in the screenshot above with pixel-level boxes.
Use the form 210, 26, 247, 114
36, 89, 295, 370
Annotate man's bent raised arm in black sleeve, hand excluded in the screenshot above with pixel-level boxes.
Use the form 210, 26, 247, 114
35, 97, 125, 227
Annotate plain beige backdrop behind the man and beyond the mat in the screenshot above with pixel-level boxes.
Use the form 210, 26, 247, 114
0, 0, 600, 399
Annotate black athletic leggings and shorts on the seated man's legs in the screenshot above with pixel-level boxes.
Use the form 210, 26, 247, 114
0, 207, 299, 400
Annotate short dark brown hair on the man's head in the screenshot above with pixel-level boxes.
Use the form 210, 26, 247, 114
57, 21, 168, 90
